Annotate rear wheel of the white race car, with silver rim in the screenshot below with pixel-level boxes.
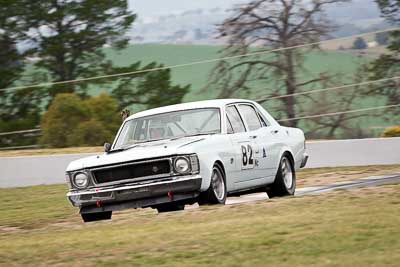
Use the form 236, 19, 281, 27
267, 154, 296, 198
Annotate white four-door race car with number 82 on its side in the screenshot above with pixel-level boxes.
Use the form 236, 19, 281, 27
66, 99, 308, 222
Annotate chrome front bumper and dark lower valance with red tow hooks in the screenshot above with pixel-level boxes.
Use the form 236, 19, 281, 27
67, 175, 201, 213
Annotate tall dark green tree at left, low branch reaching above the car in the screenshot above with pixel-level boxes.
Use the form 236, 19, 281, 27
17, 0, 187, 110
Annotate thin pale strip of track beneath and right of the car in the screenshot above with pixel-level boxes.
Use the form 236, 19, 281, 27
226, 173, 400, 205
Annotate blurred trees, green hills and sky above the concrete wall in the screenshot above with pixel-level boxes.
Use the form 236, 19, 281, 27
0, 0, 400, 150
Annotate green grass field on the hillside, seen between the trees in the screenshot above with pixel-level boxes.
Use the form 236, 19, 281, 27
16, 44, 396, 137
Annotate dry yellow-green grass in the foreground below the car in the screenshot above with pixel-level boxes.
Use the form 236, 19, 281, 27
0, 168, 400, 267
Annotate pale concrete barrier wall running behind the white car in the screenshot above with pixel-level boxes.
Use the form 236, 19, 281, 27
0, 137, 400, 188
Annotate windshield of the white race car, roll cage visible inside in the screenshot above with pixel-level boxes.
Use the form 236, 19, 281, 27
113, 108, 221, 150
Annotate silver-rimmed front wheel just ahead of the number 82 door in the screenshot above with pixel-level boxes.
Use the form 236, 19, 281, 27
198, 165, 227, 205
